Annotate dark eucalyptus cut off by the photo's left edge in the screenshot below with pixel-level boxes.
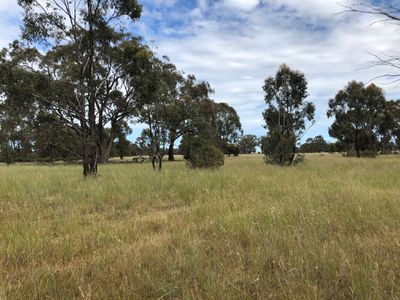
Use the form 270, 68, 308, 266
0, 42, 43, 159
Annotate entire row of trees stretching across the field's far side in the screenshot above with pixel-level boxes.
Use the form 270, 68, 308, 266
0, 0, 400, 176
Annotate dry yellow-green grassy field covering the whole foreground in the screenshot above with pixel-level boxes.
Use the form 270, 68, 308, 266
0, 154, 400, 299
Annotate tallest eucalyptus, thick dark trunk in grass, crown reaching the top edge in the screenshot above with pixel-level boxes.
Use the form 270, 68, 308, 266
18, 0, 142, 176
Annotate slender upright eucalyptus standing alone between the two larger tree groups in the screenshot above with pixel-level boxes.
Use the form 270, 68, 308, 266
262, 65, 315, 165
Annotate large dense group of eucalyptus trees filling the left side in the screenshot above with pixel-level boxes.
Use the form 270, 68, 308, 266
0, 0, 253, 176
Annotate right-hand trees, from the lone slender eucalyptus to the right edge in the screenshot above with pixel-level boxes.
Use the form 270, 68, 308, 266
261, 65, 400, 165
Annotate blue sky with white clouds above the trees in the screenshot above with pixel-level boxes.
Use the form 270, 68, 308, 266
0, 0, 400, 140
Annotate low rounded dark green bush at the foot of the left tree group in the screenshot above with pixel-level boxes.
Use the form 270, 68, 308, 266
188, 145, 224, 168
